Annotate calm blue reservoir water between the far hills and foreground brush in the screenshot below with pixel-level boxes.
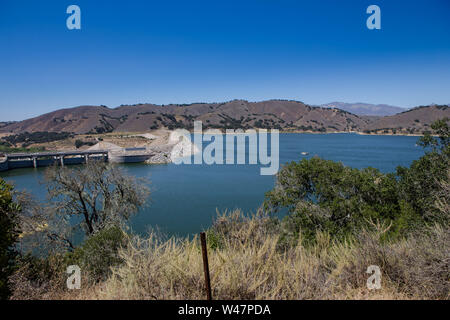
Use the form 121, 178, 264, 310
0, 134, 423, 236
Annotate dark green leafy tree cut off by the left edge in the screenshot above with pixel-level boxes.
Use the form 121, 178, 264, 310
0, 178, 20, 299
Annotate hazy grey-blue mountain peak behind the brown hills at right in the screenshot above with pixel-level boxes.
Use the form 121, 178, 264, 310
321, 102, 406, 117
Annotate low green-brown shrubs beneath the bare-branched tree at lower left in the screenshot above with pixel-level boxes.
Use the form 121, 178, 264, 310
9, 227, 127, 300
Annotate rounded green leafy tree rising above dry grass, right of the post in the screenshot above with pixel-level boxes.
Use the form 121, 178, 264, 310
265, 157, 401, 240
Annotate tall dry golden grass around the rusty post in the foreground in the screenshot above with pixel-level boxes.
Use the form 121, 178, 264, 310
47, 212, 450, 300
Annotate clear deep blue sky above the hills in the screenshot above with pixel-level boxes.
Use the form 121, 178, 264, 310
0, 0, 450, 121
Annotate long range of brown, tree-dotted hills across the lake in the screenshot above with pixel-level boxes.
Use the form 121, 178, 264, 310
0, 100, 450, 134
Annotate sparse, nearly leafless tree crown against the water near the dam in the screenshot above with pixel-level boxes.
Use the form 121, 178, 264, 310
45, 161, 149, 241
